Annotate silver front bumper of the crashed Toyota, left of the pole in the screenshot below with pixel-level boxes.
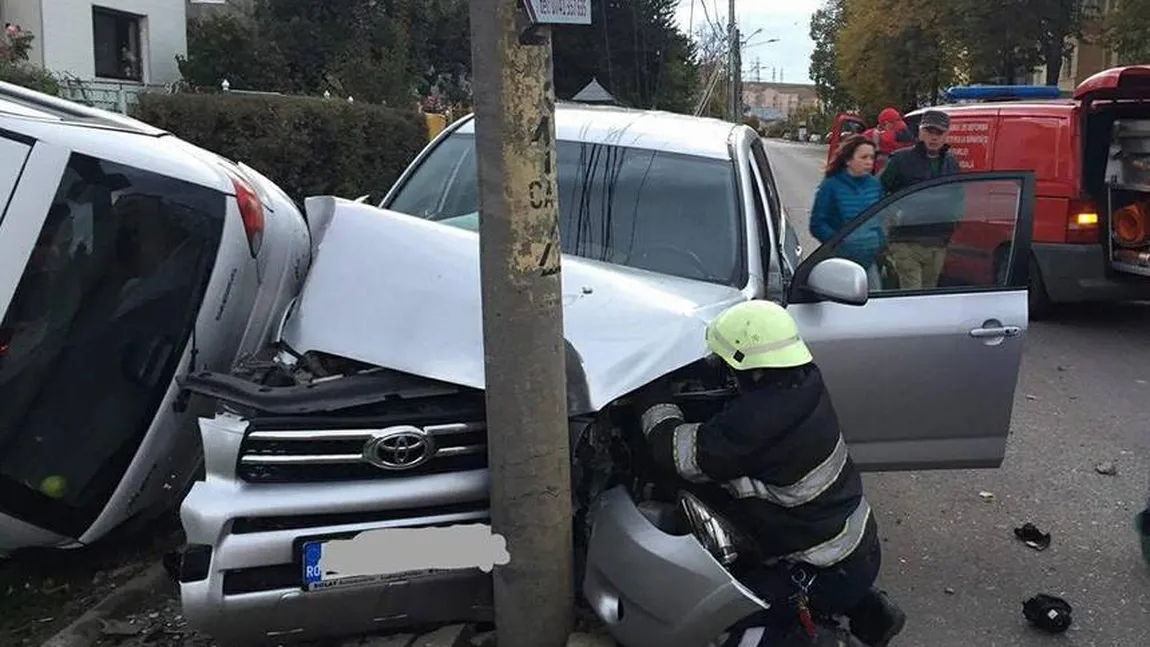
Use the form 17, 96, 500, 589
179, 470, 493, 647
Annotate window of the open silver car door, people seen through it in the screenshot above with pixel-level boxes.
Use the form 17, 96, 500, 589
809, 177, 1024, 298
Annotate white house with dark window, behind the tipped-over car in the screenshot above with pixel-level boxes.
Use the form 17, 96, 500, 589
0, 0, 187, 85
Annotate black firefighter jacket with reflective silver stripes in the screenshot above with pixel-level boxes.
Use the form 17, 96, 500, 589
641, 363, 874, 568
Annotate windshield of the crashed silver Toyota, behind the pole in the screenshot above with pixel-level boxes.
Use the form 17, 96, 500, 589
384, 133, 745, 287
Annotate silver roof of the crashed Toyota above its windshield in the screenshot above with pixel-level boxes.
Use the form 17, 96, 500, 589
458, 102, 737, 160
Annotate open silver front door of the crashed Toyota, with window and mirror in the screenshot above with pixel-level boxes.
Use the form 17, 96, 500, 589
788, 171, 1035, 470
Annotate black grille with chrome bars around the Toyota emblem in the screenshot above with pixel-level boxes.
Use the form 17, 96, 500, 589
238, 421, 488, 483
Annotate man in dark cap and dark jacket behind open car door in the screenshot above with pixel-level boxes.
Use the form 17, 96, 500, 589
879, 110, 963, 290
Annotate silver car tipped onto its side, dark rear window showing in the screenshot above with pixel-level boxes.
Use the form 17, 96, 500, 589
0, 83, 311, 554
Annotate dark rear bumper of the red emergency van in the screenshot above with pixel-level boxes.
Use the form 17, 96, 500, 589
1030, 242, 1150, 303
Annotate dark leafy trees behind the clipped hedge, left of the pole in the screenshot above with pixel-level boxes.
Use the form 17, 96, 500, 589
178, 0, 470, 105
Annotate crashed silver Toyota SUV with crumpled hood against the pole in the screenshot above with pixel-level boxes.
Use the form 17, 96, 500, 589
174, 105, 1034, 647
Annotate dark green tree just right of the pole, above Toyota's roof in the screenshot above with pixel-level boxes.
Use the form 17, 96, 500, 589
552, 0, 698, 111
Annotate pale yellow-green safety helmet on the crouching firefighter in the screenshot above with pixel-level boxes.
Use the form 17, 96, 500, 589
707, 301, 813, 371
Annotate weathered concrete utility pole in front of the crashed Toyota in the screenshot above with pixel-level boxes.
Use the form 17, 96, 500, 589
470, 0, 572, 647
